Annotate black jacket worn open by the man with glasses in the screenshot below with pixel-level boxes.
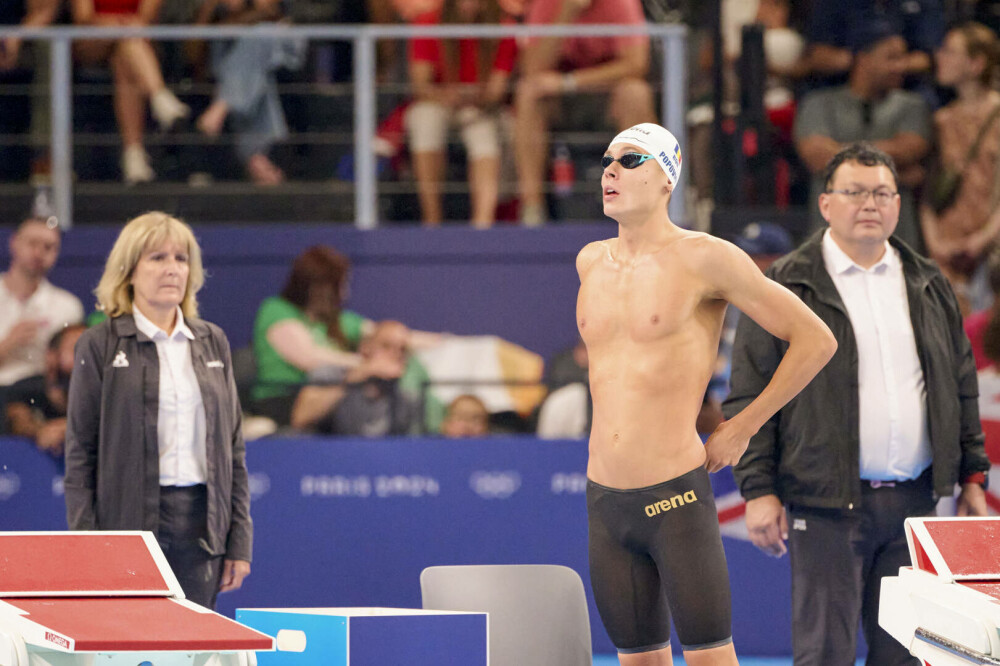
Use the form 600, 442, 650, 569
723, 231, 990, 509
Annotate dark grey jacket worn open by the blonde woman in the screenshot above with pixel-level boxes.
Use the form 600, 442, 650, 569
64, 315, 253, 562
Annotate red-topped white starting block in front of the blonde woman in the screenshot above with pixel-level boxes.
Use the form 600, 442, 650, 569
0, 532, 274, 666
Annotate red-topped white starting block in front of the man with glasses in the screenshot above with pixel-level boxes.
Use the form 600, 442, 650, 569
878, 518, 1000, 666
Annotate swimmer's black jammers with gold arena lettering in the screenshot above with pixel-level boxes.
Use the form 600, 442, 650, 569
587, 467, 732, 653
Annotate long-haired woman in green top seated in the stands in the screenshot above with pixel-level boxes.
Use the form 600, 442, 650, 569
253, 245, 440, 425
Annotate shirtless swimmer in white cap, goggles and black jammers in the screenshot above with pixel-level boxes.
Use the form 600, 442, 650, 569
576, 123, 836, 666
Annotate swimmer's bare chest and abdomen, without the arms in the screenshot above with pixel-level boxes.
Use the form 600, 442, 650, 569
577, 241, 725, 487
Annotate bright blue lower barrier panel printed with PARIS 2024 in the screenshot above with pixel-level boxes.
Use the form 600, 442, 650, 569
0, 437, 790, 655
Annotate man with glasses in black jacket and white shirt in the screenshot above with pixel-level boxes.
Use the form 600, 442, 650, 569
723, 143, 990, 666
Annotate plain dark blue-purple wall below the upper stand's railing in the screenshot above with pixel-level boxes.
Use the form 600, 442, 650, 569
0, 223, 617, 357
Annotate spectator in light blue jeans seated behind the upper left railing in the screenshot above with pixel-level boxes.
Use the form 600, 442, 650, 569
197, 0, 307, 185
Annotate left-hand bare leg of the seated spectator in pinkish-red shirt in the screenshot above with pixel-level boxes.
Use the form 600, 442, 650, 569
514, 78, 555, 226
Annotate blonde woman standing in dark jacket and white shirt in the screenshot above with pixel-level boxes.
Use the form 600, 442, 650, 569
65, 212, 253, 608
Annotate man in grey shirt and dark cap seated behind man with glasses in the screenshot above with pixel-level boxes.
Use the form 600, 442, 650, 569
795, 20, 932, 252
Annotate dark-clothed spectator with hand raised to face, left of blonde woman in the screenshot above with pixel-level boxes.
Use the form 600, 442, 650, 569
4, 324, 87, 456
